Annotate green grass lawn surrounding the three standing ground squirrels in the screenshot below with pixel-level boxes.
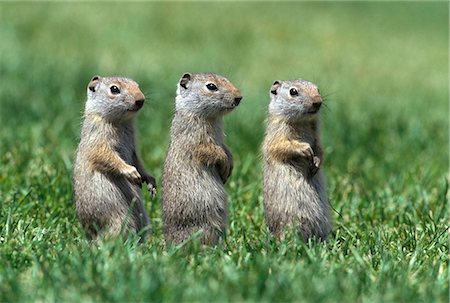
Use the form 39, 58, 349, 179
0, 2, 449, 302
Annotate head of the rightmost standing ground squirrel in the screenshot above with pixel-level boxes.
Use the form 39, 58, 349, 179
269, 79, 322, 121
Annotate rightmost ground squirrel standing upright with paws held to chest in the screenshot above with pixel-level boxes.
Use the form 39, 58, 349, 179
263, 79, 331, 240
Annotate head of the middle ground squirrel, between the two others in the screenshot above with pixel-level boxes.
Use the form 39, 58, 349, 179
175, 73, 242, 118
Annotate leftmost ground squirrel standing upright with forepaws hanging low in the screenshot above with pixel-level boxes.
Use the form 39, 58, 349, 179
73, 76, 156, 240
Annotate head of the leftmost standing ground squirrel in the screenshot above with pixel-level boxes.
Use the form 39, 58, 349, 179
85, 76, 145, 121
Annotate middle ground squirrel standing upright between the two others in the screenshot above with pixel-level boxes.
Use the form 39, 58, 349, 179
162, 73, 242, 244
